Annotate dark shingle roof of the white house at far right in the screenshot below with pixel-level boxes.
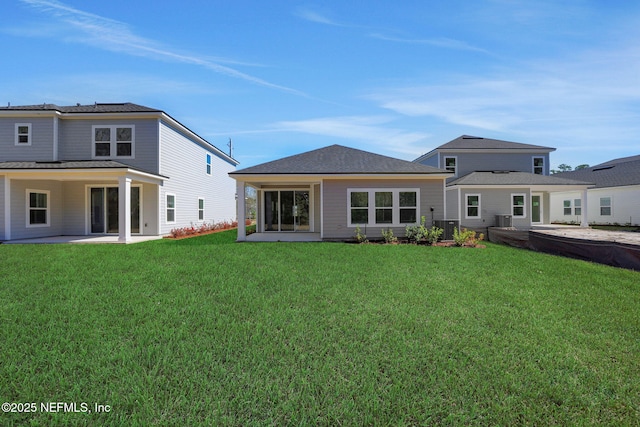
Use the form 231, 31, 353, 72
553, 156, 640, 188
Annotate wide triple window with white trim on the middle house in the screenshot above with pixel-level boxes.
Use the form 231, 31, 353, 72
347, 188, 420, 227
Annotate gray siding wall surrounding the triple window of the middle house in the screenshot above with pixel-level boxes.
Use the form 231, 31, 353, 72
323, 179, 444, 240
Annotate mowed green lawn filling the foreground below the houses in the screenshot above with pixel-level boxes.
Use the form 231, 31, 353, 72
0, 231, 640, 426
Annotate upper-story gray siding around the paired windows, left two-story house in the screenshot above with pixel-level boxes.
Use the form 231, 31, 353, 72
58, 118, 159, 174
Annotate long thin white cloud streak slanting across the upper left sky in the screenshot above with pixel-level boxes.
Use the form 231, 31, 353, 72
13, 0, 307, 97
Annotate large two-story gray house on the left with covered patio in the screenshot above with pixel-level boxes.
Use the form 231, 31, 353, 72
0, 103, 238, 242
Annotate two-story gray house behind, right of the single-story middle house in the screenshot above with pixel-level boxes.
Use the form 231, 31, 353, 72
414, 135, 590, 230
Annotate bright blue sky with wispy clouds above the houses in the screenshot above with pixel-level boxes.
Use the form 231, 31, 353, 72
0, 0, 640, 168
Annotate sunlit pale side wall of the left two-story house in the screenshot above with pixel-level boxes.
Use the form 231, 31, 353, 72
159, 122, 237, 234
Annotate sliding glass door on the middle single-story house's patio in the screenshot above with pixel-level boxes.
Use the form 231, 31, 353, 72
264, 190, 310, 231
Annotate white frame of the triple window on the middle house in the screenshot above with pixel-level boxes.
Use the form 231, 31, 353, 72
347, 187, 420, 228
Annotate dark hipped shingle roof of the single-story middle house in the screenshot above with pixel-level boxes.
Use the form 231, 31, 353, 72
230, 145, 448, 175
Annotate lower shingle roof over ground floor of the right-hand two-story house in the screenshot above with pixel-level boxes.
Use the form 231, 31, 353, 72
448, 171, 591, 186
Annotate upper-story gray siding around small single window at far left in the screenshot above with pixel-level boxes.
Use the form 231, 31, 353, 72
0, 117, 55, 162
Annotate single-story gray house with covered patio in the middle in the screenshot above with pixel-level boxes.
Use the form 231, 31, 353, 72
229, 145, 451, 241
